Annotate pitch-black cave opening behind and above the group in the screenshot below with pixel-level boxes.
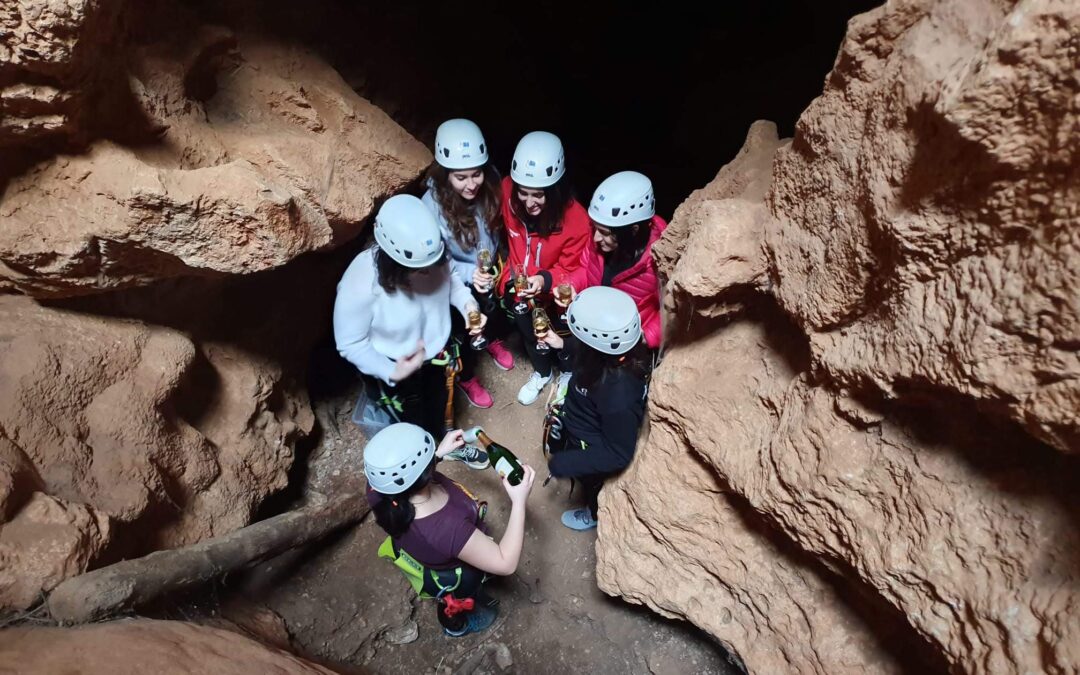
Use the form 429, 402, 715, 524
200, 0, 879, 218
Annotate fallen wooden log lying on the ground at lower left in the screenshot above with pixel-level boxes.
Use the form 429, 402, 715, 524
49, 495, 368, 623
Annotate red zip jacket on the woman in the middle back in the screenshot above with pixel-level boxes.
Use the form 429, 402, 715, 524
496, 177, 592, 294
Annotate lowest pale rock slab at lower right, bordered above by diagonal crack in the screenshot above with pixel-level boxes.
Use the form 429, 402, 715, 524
596, 412, 902, 675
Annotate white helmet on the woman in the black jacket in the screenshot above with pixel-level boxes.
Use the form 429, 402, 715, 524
566, 286, 642, 354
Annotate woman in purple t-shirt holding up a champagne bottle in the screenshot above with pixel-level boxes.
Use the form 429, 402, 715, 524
364, 422, 536, 637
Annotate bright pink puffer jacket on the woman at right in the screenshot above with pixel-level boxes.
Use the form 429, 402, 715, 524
570, 216, 667, 349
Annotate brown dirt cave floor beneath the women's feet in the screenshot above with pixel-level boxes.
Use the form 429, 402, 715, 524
223, 341, 738, 674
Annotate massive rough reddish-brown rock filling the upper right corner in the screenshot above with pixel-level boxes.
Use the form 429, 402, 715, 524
766, 0, 1080, 451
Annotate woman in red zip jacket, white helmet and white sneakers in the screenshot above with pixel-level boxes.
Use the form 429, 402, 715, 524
473, 132, 589, 405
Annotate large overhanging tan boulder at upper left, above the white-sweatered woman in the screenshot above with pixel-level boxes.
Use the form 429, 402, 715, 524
0, 19, 431, 297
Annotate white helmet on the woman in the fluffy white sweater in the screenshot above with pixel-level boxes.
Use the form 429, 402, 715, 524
375, 194, 443, 269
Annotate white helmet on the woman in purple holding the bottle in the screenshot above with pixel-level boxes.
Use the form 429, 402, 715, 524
364, 422, 435, 495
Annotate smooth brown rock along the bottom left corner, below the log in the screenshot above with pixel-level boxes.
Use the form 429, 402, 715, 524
0, 619, 334, 675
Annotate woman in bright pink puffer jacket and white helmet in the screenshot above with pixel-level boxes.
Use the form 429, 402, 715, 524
555, 171, 667, 350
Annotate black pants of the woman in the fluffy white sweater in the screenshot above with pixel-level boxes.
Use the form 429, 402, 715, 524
364, 361, 447, 444
